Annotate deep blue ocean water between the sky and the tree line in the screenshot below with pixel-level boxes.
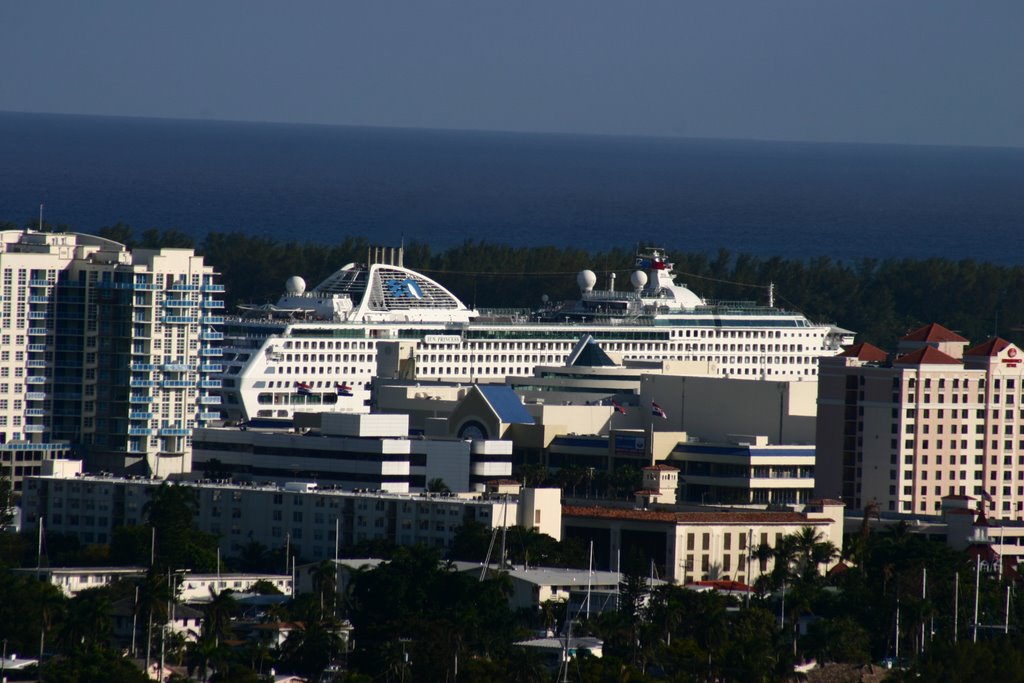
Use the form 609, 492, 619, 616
0, 114, 1024, 264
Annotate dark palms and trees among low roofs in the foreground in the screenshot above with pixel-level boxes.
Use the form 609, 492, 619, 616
0, 485, 1024, 683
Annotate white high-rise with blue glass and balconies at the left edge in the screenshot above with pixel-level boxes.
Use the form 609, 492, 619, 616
0, 230, 223, 486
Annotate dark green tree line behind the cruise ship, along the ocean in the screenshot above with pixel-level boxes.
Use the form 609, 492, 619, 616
6, 218, 1024, 348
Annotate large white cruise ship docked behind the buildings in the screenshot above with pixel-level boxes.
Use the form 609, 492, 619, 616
221, 249, 854, 423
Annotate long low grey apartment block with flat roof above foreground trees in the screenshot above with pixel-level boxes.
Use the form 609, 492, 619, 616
22, 468, 560, 560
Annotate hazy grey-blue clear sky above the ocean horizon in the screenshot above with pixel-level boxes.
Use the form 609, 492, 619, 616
0, 0, 1024, 146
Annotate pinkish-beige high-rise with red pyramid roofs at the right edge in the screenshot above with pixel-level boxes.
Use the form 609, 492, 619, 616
815, 324, 1024, 519
